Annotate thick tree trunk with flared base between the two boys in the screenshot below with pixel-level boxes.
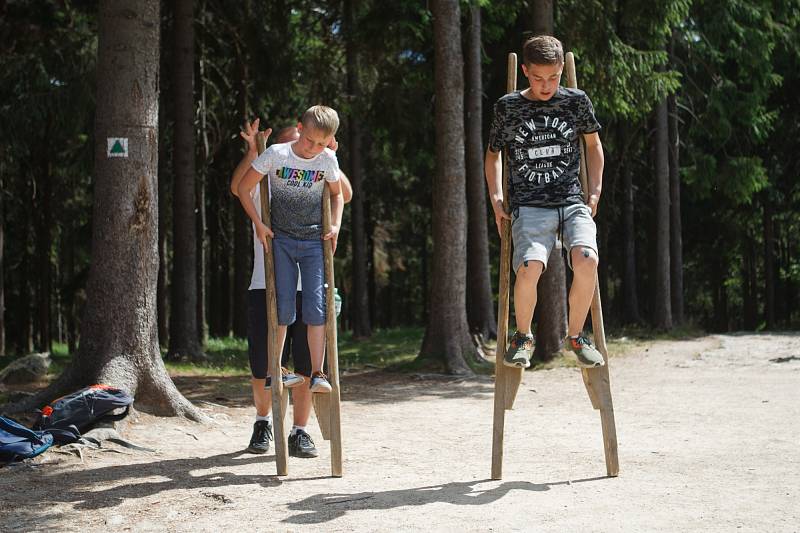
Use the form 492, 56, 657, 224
420, 0, 477, 374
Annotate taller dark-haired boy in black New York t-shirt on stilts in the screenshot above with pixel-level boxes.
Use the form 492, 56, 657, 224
485, 36, 605, 368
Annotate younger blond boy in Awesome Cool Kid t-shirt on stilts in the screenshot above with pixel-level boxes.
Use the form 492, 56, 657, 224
238, 106, 343, 400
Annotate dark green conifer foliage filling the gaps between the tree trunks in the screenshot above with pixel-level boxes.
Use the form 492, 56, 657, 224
0, 0, 800, 362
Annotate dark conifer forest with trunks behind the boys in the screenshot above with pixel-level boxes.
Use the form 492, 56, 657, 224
0, 0, 800, 384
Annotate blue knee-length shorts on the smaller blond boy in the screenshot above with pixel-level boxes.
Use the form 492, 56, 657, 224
272, 233, 325, 326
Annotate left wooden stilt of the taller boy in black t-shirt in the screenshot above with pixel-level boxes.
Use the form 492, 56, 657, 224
492, 53, 522, 479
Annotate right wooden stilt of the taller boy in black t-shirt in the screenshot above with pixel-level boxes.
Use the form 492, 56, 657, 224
564, 52, 619, 477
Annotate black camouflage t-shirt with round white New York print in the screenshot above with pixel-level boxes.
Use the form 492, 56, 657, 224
489, 87, 600, 209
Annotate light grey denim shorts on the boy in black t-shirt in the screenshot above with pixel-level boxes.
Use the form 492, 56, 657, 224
511, 204, 597, 272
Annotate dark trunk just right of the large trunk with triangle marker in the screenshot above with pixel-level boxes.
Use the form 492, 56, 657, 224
167, 0, 205, 361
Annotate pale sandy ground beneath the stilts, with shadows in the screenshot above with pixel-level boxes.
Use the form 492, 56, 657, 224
0, 334, 800, 532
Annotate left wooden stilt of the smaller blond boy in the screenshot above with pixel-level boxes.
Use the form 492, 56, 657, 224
256, 133, 289, 476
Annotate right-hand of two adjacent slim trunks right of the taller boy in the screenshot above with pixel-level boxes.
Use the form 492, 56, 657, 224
667, 90, 683, 324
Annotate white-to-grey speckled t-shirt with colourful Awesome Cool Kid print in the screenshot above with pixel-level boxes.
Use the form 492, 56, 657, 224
252, 141, 339, 240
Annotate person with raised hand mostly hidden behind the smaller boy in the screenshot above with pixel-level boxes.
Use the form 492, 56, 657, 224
231, 119, 353, 457
